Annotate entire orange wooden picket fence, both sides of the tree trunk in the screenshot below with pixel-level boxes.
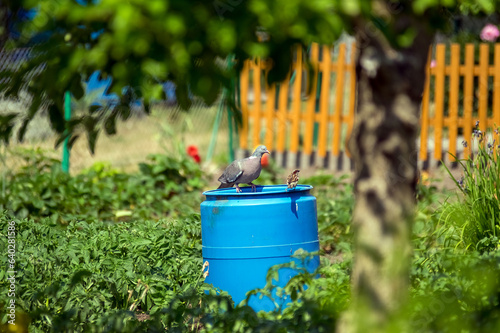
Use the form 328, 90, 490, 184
239, 44, 500, 169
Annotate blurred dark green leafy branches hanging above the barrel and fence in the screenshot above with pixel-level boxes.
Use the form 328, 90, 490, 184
0, 0, 342, 151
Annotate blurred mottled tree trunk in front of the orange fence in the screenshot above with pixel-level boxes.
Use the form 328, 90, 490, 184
338, 17, 433, 332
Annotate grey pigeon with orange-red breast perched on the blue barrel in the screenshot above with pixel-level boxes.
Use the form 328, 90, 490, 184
218, 146, 269, 193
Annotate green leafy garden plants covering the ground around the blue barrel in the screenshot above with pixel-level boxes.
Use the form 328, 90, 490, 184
0, 146, 500, 332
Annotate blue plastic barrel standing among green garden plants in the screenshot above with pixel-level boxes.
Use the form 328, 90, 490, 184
201, 185, 319, 311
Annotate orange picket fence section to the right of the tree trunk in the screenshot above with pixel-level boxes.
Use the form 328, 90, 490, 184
419, 44, 500, 160
